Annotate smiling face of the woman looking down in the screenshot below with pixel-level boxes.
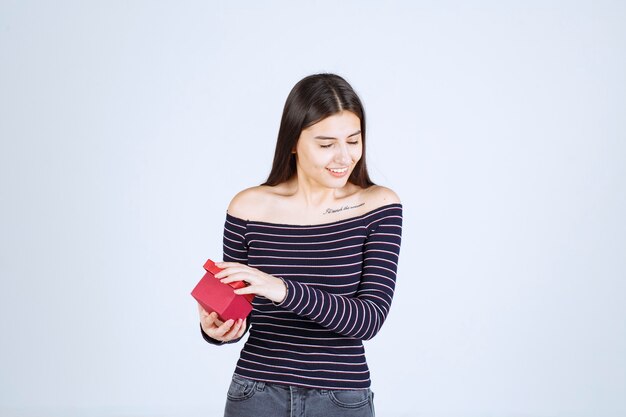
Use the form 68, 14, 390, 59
295, 111, 363, 188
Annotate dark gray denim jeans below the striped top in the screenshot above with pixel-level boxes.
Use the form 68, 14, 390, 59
224, 374, 374, 417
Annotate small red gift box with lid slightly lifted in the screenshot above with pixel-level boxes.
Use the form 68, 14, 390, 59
191, 259, 254, 321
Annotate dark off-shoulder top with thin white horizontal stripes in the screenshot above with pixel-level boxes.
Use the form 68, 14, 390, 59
205, 203, 402, 389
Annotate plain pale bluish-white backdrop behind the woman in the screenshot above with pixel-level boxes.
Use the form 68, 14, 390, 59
0, 0, 626, 417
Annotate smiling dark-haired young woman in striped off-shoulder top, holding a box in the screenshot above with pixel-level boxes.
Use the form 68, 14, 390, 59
199, 74, 402, 417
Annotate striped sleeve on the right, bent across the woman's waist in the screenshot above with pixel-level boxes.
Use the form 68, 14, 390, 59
276, 205, 402, 340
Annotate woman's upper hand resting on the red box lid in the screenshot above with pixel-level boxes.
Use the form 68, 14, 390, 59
215, 262, 287, 303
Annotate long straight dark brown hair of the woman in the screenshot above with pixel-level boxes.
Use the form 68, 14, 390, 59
262, 74, 374, 188
